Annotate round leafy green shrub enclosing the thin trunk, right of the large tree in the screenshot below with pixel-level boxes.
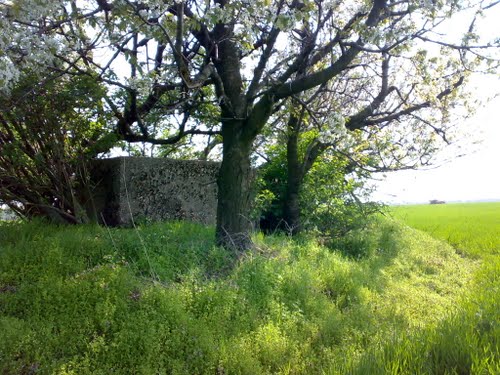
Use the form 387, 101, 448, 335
259, 130, 378, 238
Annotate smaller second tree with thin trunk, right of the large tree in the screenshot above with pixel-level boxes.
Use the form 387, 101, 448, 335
259, 60, 450, 235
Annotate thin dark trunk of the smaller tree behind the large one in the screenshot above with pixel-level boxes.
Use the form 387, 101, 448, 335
283, 116, 303, 235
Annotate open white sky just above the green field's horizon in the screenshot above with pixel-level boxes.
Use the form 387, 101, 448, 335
372, 94, 500, 204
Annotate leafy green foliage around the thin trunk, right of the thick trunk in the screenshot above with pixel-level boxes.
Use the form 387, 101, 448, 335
257, 132, 380, 238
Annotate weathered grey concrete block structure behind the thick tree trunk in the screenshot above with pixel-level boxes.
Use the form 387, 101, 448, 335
87, 157, 220, 226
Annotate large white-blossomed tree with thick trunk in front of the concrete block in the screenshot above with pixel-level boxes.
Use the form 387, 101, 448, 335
2, 0, 496, 250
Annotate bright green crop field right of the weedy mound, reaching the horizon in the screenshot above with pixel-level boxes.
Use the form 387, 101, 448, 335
371, 202, 500, 374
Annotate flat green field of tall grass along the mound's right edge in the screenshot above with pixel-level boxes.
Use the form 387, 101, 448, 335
356, 203, 500, 374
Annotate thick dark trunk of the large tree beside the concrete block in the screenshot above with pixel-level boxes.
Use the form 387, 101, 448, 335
216, 121, 253, 252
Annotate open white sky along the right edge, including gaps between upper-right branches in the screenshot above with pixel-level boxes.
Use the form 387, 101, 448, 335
372, 6, 500, 204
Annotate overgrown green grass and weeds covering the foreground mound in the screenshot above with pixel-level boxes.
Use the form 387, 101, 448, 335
0, 210, 500, 374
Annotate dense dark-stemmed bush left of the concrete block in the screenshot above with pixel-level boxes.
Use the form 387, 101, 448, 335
0, 77, 115, 223
